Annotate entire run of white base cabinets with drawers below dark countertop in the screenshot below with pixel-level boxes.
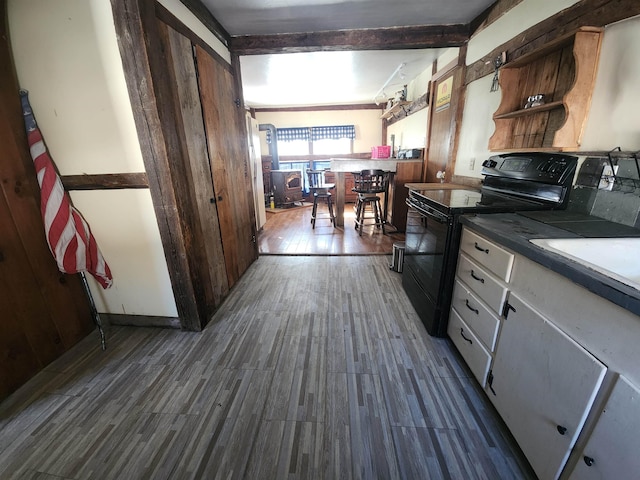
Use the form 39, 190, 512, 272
458, 227, 640, 480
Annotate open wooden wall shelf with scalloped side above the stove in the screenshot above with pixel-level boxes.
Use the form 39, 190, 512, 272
489, 27, 603, 151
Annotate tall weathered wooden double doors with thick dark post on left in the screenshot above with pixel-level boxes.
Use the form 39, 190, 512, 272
111, 0, 258, 331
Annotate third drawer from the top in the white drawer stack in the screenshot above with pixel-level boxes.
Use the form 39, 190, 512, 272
451, 280, 500, 352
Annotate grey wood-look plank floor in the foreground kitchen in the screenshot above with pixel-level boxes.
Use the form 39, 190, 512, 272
0, 255, 533, 480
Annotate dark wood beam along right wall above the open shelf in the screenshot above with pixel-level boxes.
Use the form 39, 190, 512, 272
465, 0, 640, 84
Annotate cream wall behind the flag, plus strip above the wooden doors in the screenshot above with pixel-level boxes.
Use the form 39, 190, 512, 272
8, 0, 228, 317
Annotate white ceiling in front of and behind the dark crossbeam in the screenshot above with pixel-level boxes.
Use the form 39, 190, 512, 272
202, 0, 495, 107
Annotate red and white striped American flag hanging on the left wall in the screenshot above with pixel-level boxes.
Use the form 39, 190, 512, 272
20, 90, 113, 288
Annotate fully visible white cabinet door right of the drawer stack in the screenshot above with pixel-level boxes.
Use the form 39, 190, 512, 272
489, 294, 606, 480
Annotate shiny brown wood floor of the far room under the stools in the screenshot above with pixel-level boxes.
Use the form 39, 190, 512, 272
258, 204, 404, 255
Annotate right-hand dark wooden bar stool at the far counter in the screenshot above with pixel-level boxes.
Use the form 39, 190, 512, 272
352, 170, 389, 236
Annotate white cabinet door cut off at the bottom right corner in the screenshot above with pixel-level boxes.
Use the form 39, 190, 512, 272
570, 377, 640, 480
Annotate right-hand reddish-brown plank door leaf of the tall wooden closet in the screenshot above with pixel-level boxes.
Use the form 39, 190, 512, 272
196, 46, 257, 287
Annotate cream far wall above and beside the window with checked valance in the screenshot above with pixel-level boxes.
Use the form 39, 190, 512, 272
256, 110, 382, 155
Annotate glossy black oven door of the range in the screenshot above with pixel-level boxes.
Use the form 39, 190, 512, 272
402, 205, 453, 336
